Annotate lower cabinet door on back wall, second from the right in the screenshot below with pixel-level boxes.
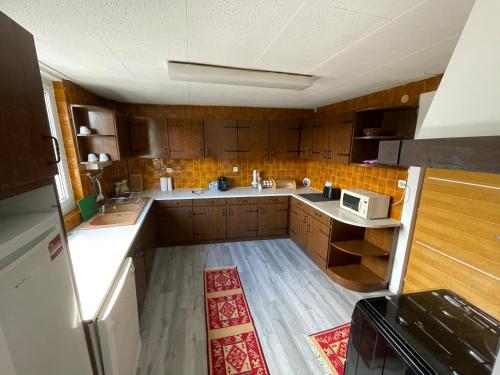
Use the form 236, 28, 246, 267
227, 204, 259, 238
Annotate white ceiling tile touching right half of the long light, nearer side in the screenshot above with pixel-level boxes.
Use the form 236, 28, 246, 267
258, 3, 387, 73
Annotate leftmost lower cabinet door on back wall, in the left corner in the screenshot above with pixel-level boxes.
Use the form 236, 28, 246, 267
158, 207, 193, 244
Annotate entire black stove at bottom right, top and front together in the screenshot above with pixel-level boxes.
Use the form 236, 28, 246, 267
344, 289, 500, 375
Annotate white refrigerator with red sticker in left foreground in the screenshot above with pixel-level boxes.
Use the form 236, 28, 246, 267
0, 185, 92, 375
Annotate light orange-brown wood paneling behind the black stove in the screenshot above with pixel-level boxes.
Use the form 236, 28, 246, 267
404, 169, 500, 318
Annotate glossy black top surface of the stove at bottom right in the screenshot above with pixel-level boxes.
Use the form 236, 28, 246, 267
360, 289, 500, 375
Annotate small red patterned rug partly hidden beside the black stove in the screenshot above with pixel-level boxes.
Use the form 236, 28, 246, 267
307, 323, 351, 375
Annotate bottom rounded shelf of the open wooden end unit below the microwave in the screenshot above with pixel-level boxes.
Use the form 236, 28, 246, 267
327, 263, 388, 292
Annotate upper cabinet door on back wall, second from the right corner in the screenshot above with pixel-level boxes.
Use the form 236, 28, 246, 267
238, 120, 269, 158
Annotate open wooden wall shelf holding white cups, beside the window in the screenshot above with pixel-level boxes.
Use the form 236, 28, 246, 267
70, 104, 129, 164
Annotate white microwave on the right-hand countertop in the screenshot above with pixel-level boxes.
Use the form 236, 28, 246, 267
340, 189, 391, 219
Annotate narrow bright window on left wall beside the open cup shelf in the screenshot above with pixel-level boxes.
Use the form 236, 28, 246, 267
43, 79, 75, 214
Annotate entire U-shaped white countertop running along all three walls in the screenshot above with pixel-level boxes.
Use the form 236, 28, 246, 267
68, 187, 401, 320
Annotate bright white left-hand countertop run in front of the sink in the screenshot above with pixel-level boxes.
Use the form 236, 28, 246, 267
68, 199, 154, 320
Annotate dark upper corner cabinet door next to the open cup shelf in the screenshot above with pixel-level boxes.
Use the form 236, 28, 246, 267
127, 117, 166, 158
